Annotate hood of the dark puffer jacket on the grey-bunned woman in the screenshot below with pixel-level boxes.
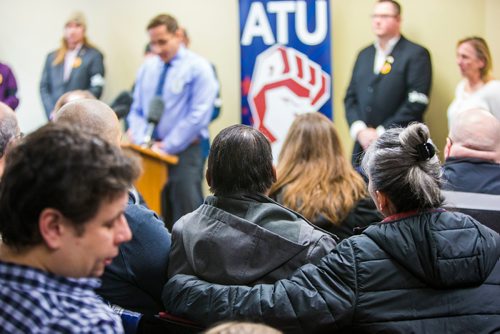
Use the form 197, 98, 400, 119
363, 209, 500, 288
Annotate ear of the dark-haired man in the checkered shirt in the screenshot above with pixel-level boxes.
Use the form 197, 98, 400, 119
38, 208, 66, 249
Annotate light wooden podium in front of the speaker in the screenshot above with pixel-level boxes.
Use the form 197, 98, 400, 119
122, 144, 179, 215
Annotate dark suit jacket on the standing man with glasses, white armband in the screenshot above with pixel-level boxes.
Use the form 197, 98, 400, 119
344, 36, 432, 164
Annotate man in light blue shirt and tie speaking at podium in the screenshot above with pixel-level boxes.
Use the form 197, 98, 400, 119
127, 14, 218, 228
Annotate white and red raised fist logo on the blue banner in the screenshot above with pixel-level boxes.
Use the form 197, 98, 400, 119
248, 45, 330, 159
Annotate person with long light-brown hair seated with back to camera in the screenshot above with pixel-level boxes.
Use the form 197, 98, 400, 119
270, 112, 382, 239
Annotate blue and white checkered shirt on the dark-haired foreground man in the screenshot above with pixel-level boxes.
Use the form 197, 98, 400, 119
0, 261, 123, 333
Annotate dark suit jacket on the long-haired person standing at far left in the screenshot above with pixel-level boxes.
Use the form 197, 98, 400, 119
40, 46, 104, 117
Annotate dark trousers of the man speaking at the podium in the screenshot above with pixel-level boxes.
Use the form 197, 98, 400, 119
161, 143, 205, 231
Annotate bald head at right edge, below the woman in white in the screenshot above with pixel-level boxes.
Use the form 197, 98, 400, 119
449, 108, 500, 162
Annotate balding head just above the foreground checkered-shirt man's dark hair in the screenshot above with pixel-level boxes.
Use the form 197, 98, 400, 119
54, 99, 121, 145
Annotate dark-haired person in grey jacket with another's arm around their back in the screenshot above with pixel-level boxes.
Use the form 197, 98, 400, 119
168, 125, 336, 285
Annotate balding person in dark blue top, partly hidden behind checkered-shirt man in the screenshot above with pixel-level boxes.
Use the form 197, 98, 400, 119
54, 99, 170, 314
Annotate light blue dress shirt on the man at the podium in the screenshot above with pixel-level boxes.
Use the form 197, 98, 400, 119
128, 46, 219, 154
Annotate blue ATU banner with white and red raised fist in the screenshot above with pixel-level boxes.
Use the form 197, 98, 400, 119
240, 0, 332, 160
